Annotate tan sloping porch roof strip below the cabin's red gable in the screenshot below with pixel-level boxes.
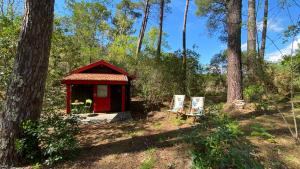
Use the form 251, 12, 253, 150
63, 73, 128, 82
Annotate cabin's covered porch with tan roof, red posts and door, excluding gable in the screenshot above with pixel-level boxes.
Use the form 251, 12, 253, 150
63, 73, 130, 113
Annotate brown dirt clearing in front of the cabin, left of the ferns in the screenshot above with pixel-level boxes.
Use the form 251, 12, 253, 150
57, 112, 196, 169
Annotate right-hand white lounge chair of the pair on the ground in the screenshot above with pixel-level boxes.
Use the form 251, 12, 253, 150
186, 97, 204, 122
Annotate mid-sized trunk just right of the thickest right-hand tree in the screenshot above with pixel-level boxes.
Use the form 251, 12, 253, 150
247, 0, 256, 80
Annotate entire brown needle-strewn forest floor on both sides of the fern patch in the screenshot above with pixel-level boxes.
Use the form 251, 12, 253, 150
55, 102, 300, 169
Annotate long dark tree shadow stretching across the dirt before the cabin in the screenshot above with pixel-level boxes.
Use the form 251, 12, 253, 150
64, 127, 193, 168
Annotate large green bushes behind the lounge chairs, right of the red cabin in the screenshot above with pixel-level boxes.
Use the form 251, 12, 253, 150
132, 46, 203, 105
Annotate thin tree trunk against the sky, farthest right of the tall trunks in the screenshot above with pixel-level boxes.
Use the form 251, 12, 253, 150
259, 0, 269, 61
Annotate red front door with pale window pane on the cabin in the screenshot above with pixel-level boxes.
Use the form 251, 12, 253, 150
94, 85, 110, 112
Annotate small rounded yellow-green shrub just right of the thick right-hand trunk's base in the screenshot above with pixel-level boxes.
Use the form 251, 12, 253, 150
244, 85, 265, 102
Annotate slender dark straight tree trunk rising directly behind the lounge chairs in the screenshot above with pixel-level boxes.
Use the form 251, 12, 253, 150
182, 0, 190, 93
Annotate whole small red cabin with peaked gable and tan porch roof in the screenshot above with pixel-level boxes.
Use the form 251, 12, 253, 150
62, 60, 132, 113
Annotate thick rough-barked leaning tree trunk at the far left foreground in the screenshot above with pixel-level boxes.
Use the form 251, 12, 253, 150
0, 0, 54, 167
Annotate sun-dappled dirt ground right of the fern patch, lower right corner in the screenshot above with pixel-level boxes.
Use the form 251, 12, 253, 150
236, 104, 300, 169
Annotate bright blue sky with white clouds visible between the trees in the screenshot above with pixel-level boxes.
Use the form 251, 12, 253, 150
55, 0, 300, 64
